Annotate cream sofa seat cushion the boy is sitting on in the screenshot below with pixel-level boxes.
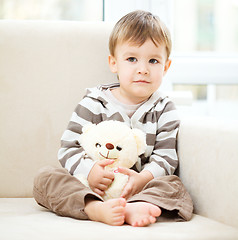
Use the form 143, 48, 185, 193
0, 198, 238, 240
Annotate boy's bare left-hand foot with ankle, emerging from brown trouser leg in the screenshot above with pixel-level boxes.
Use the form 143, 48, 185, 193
84, 198, 126, 226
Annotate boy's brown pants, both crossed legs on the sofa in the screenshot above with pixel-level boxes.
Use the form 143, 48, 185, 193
33, 167, 193, 221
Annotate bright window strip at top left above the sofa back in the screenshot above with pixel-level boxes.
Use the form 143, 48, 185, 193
0, 0, 103, 21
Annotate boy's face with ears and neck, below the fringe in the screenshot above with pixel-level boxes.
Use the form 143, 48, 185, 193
109, 39, 171, 104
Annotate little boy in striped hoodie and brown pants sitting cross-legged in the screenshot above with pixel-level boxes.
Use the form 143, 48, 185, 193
34, 11, 193, 226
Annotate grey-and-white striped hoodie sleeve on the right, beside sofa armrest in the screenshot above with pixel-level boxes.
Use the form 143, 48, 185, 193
143, 101, 180, 177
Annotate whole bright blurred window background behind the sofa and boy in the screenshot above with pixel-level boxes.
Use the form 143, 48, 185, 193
0, 0, 238, 119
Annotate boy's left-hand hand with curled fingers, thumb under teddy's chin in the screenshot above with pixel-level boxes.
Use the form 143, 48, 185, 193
88, 159, 114, 196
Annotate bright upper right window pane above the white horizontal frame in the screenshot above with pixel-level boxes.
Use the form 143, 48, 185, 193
173, 0, 238, 53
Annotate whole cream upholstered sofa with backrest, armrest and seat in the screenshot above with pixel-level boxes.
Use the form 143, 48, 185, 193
0, 20, 238, 240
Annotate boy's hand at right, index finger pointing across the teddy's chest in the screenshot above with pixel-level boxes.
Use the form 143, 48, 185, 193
118, 168, 154, 199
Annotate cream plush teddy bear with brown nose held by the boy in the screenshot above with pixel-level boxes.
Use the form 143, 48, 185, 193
75, 120, 146, 200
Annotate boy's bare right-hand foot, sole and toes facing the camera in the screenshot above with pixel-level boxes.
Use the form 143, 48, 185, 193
125, 202, 161, 227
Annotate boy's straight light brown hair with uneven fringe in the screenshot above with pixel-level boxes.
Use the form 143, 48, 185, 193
109, 10, 172, 59
